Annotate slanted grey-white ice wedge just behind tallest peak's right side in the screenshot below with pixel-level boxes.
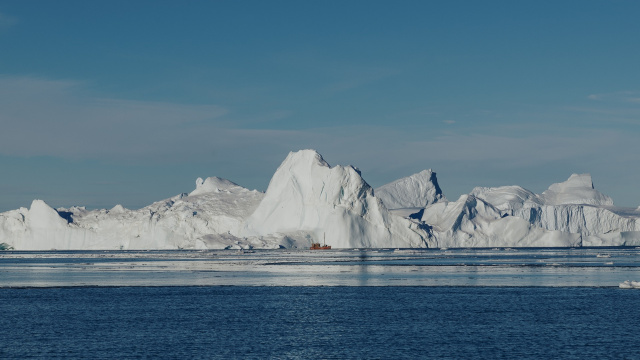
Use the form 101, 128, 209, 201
375, 169, 447, 209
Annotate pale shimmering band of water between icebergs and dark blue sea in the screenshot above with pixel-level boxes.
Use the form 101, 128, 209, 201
0, 248, 640, 287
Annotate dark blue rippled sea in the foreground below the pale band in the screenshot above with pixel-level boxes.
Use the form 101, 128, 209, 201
0, 286, 640, 359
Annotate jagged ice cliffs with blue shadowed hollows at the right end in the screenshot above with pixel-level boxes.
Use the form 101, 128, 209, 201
421, 174, 640, 247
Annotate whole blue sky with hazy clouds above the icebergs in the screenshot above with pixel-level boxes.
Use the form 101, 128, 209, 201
0, 0, 640, 211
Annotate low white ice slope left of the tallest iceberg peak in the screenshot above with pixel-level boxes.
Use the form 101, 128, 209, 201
0, 178, 270, 250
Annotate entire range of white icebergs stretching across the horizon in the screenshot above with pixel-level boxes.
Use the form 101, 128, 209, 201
0, 150, 640, 250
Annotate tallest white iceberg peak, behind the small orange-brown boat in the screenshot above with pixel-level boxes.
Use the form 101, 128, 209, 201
244, 150, 429, 248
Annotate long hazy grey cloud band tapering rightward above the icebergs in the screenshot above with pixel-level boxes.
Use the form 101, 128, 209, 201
0, 77, 640, 170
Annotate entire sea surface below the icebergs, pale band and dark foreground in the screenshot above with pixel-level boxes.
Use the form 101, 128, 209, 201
0, 248, 640, 359
